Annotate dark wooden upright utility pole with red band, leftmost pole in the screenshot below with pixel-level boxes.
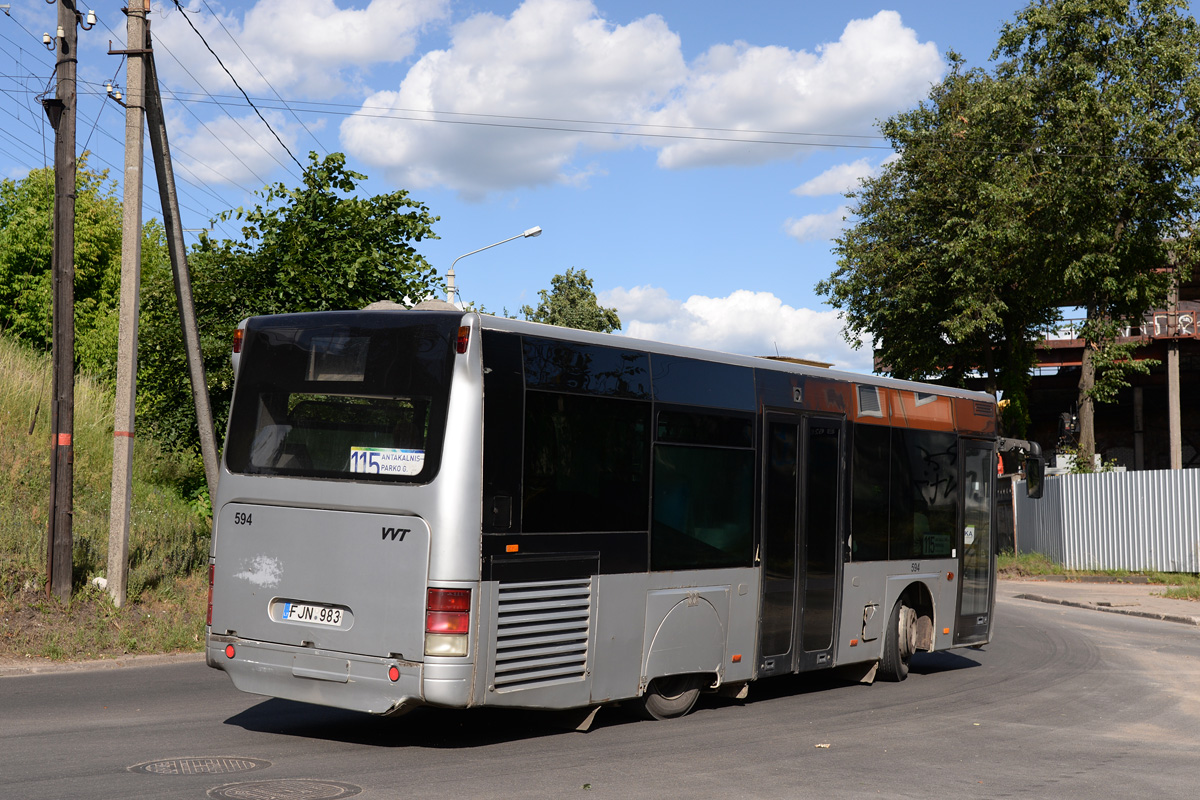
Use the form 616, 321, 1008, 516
43, 0, 79, 602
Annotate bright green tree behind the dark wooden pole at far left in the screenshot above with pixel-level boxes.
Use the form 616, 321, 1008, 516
0, 154, 121, 372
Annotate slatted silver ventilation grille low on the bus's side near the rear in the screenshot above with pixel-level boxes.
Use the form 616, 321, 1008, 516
492, 578, 592, 691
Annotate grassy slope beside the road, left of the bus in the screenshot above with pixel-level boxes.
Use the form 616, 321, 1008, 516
0, 336, 210, 660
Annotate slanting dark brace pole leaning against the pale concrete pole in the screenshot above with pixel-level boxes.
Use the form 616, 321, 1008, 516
145, 31, 220, 499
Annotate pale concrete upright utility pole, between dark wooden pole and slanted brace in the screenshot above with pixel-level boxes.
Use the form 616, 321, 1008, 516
108, 0, 150, 608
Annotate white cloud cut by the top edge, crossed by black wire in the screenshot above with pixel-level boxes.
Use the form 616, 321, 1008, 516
154, 0, 449, 98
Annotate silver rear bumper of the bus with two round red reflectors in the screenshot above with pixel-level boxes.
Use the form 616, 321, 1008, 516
205, 634, 424, 714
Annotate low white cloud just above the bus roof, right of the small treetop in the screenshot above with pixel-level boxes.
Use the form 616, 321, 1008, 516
599, 285, 871, 372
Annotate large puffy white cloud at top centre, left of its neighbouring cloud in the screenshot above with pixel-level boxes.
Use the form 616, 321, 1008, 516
342, 0, 685, 196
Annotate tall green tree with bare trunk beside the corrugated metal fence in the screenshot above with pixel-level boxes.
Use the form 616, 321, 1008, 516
994, 0, 1200, 462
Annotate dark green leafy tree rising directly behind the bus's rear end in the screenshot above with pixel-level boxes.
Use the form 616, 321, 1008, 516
138, 154, 438, 449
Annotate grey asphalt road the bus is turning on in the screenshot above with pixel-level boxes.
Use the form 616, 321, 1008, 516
0, 599, 1200, 800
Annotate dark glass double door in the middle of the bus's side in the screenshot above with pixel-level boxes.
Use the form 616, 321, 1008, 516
758, 413, 844, 676
